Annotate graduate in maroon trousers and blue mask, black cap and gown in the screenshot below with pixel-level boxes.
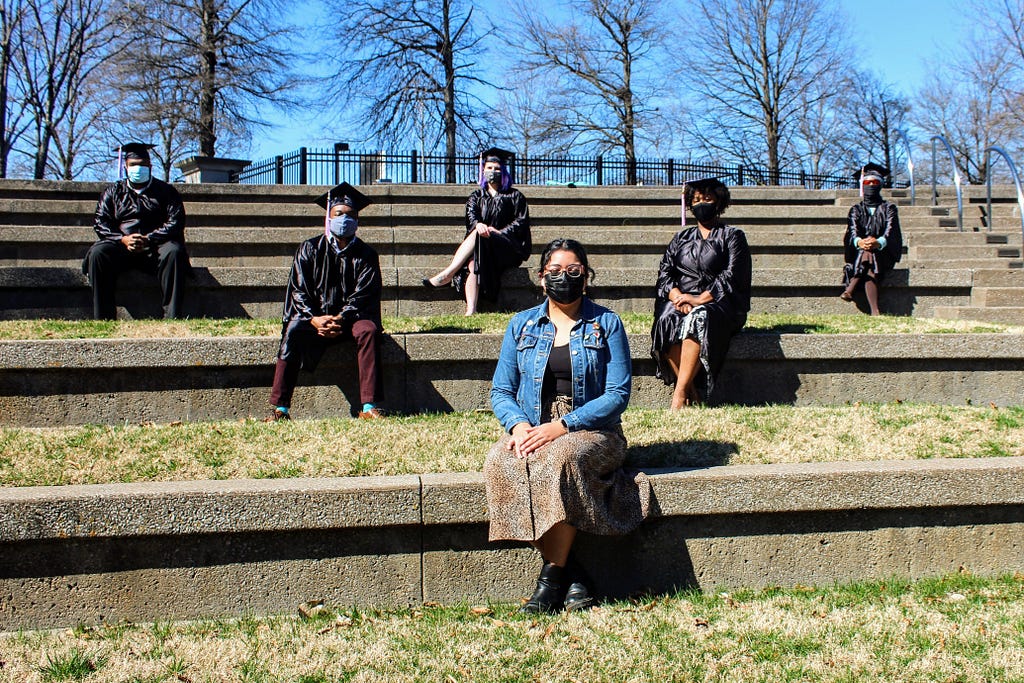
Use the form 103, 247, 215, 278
267, 182, 383, 421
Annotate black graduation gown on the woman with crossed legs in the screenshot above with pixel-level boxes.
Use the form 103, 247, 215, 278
455, 187, 532, 301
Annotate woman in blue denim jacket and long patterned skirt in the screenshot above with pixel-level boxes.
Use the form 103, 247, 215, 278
483, 240, 650, 612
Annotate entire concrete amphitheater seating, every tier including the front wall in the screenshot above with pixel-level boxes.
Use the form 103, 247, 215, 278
0, 181, 1024, 631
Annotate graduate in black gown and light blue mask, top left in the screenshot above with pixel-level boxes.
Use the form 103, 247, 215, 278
82, 142, 191, 321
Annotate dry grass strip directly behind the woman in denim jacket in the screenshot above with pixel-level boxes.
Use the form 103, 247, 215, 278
0, 403, 1024, 486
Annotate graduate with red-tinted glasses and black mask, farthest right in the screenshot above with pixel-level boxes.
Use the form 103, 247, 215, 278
839, 164, 903, 315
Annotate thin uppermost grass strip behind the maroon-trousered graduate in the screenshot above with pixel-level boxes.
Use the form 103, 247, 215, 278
0, 312, 1024, 340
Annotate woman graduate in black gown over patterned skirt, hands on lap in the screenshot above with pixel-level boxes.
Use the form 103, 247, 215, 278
650, 178, 751, 410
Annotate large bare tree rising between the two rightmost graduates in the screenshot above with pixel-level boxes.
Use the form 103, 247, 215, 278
681, 0, 844, 184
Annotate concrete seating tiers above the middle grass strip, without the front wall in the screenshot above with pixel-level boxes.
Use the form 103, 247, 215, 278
0, 180, 1024, 426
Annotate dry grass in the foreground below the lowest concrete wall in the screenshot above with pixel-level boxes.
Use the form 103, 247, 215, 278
0, 574, 1024, 683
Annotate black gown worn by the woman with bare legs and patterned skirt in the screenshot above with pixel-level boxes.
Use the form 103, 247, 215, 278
650, 225, 751, 400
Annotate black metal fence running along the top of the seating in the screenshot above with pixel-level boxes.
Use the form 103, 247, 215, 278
232, 144, 856, 189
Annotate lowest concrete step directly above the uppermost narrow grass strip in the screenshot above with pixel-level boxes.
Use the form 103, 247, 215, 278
0, 267, 972, 319
